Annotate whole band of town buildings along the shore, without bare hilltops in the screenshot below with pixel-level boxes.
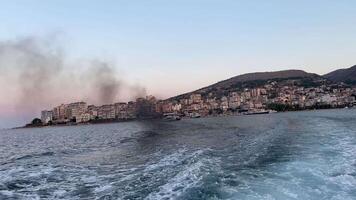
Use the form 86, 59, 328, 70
41, 81, 356, 124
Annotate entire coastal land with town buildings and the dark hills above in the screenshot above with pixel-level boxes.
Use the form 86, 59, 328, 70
34, 66, 356, 125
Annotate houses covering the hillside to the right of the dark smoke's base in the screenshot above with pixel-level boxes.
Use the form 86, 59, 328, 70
161, 81, 356, 116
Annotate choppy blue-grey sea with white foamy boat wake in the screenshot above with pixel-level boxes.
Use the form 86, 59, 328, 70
0, 109, 356, 200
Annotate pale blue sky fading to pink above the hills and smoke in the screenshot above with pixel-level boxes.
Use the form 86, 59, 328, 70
0, 0, 356, 128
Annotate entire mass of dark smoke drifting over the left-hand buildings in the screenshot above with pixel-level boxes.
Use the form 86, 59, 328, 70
0, 37, 146, 114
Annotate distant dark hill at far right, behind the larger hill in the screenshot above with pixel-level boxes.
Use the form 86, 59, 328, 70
324, 65, 356, 84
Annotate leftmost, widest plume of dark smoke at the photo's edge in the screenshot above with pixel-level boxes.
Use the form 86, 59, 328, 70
0, 38, 63, 111
